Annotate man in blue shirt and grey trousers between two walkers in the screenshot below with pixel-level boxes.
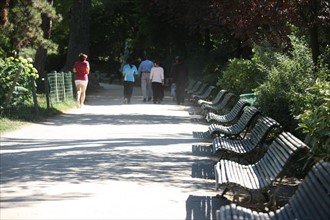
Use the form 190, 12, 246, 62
138, 57, 155, 102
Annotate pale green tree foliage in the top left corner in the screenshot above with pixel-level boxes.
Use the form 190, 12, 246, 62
0, 0, 62, 58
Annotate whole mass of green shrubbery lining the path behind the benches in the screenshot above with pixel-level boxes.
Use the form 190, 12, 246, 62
218, 36, 330, 164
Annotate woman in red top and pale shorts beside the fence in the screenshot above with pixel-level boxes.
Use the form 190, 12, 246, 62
73, 53, 90, 108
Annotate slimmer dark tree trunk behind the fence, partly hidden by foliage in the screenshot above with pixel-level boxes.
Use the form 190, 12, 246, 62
34, 0, 53, 92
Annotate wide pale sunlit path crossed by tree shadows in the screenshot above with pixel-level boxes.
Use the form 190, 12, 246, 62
0, 85, 224, 220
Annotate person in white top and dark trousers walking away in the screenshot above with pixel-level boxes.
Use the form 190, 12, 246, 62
150, 60, 164, 104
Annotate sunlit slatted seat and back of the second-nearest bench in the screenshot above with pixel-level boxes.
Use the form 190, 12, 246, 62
215, 132, 307, 195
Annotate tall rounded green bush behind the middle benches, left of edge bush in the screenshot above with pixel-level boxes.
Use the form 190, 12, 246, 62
255, 36, 315, 131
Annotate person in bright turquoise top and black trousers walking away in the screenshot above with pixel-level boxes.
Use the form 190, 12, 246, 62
122, 58, 139, 104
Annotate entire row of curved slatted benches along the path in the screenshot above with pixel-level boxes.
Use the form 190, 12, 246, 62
186, 81, 330, 219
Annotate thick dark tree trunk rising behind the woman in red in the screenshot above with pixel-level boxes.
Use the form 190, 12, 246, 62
62, 0, 91, 72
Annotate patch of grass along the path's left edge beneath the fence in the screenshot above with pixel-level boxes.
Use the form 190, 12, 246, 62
0, 95, 75, 132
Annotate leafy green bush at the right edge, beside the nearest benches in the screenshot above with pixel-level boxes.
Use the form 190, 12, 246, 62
296, 47, 330, 164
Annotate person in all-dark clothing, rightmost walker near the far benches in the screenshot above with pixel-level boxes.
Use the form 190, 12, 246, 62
171, 56, 188, 105
